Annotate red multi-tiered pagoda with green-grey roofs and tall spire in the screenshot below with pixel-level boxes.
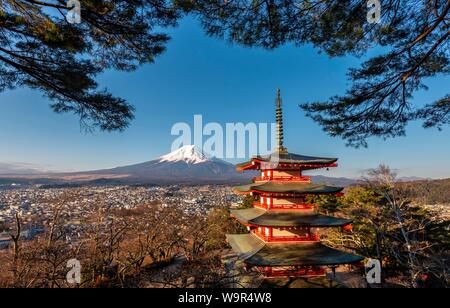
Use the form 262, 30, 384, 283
227, 90, 362, 277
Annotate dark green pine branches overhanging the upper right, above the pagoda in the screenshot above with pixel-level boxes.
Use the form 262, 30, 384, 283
187, 0, 450, 146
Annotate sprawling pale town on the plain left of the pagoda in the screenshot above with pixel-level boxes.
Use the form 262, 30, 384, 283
0, 185, 241, 249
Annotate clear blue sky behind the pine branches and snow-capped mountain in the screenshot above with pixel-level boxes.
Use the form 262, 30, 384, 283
0, 16, 450, 178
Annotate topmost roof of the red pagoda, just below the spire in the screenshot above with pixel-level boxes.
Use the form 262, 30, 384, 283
236, 152, 338, 170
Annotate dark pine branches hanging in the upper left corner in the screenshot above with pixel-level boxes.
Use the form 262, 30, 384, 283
0, 0, 180, 131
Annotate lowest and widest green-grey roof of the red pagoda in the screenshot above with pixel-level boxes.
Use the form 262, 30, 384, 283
227, 234, 363, 266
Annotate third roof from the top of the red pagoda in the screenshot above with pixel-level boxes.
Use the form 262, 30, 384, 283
231, 208, 351, 227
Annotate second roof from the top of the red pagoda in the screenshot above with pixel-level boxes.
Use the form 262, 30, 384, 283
234, 181, 344, 194
